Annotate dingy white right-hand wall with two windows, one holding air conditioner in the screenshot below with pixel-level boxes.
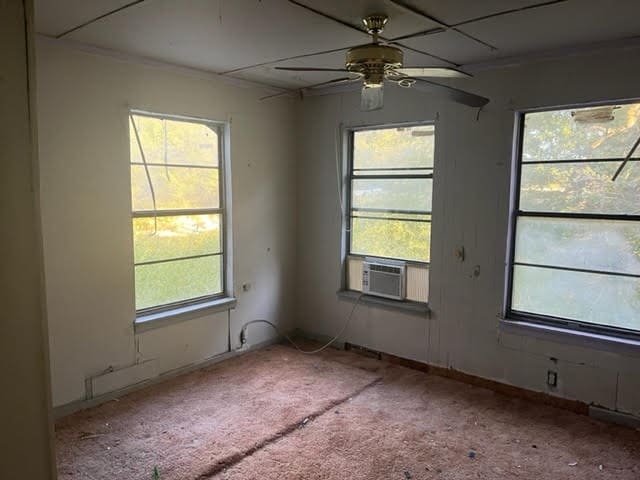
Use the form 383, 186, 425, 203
297, 50, 640, 415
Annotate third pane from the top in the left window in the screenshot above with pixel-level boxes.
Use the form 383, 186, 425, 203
133, 215, 222, 263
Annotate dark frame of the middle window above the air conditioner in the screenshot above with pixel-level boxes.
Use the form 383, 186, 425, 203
341, 121, 436, 282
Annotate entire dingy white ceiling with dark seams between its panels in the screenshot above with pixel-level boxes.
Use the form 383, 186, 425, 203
35, 0, 640, 88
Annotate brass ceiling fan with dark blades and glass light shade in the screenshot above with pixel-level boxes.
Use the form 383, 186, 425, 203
275, 14, 489, 111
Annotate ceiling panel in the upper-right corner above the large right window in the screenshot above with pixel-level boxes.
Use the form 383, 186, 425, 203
461, 0, 640, 56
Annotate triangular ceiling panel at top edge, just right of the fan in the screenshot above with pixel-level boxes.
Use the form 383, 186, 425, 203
404, 0, 543, 25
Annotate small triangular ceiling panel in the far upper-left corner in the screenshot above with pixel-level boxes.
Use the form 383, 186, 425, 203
34, 0, 131, 36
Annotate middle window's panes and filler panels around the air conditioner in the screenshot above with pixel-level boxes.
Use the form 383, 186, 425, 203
347, 125, 435, 302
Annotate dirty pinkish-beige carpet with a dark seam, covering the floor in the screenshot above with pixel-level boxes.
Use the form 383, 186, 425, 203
58, 347, 640, 480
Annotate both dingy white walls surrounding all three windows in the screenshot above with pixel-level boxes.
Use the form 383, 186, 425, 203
38, 34, 640, 415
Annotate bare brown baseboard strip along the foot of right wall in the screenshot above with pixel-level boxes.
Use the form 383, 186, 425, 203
344, 342, 589, 415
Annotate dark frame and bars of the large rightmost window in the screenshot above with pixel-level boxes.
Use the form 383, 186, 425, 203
503, 99, 640, 341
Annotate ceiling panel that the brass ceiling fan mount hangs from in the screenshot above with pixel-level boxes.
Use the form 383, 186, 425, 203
297, 0, 438, 38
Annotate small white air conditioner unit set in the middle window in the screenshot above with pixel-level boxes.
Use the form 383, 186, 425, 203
362, 258, 407, 300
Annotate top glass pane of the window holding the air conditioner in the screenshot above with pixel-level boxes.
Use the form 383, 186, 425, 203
353, 125, 435, 174
